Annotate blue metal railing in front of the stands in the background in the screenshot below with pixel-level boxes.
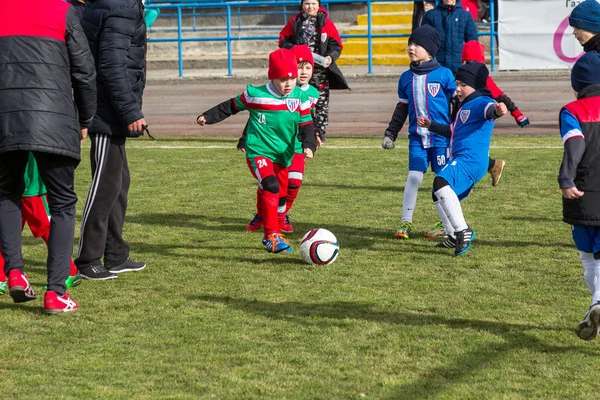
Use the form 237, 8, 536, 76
147, 0, 497, 76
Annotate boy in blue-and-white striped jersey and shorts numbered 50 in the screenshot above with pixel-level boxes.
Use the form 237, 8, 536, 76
381, 25, 456, 239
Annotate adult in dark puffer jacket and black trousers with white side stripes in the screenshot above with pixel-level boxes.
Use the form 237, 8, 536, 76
75, 0, 146, 280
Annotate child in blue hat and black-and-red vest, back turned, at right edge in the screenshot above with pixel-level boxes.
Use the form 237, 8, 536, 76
558, 51, 600, 340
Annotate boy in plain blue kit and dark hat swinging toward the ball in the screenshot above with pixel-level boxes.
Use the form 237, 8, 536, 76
418, 62, 508, 256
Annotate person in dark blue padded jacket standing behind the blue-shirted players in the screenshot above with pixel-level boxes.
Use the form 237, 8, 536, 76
423, 0, 477, 74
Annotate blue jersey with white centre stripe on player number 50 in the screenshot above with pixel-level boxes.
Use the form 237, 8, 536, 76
398, 67, 456, 149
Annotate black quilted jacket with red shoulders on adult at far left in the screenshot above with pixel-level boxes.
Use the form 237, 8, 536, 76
0, 1, 96, 160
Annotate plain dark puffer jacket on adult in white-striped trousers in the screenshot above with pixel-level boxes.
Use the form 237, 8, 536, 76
81, 0, 146, 136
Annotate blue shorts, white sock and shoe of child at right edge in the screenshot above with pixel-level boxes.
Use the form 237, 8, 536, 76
572, 226, 600, 340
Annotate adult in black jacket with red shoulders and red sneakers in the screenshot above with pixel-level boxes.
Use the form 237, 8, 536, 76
0, 0, 96, 314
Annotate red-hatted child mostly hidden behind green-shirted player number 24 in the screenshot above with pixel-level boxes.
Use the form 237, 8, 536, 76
243, 45, 319, 233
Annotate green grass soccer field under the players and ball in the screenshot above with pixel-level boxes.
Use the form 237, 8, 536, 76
0, 133, 600, 399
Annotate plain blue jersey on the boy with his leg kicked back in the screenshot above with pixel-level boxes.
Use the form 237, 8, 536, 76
450, 96, 496, 182
